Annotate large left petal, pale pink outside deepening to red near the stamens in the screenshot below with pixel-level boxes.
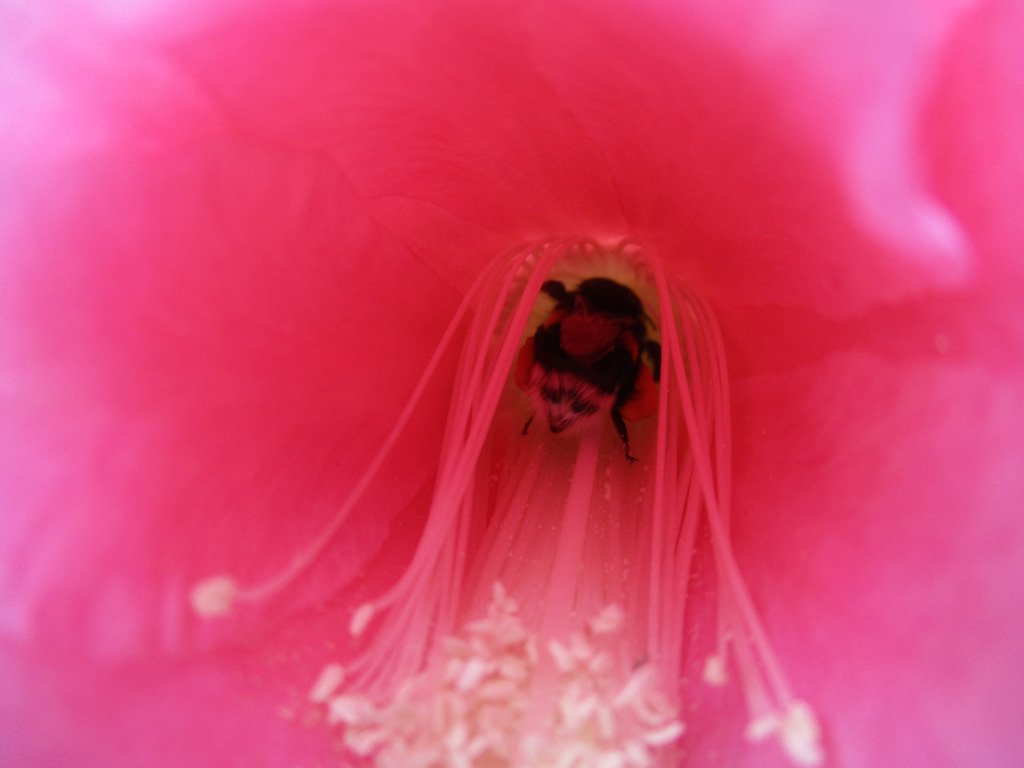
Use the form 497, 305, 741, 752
0, 110, 454, 657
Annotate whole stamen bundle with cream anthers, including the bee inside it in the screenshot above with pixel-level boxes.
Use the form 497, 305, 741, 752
193, 239, 823, 768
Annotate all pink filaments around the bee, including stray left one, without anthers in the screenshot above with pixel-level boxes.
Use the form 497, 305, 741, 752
199, 240, 815, 765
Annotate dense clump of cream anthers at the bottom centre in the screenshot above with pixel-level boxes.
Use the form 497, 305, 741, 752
311, 585, 684, 768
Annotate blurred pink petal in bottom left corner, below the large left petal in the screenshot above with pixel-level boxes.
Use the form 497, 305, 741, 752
0, 644, 325, 768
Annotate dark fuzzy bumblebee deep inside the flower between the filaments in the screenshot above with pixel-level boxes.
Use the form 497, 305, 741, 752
515, 278, 662, 463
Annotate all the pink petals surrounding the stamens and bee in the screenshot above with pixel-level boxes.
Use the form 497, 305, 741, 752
0, 0, 1024, 766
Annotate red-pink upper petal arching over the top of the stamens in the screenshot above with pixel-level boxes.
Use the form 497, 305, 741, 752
165, 2, 973, 312
